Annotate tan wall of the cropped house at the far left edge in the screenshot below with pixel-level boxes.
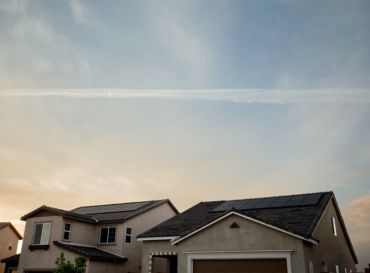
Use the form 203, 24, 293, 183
0, 226, 19, 273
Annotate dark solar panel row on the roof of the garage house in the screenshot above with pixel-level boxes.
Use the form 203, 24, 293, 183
212, 193, 323, 212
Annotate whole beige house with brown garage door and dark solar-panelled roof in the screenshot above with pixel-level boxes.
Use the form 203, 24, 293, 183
138, 192, 357, 273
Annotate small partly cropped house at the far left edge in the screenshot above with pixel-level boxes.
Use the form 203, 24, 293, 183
0, 222, 22, 273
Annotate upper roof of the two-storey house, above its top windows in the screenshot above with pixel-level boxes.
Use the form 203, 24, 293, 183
21, 199, 178, 224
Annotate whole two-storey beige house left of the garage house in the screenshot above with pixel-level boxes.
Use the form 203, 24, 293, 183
18, 199, 178, 273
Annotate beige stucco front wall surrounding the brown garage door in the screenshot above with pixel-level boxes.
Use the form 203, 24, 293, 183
142, 215, 306, 273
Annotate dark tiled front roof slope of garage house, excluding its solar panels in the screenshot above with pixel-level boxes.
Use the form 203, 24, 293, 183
138, 192, 333, 238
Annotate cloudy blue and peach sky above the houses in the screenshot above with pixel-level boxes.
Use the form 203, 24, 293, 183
0, 0, 370, 268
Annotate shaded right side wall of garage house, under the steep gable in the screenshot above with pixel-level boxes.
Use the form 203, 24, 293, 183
304, 200, 356, 273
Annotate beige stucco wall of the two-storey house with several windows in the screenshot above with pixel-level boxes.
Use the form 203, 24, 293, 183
19, 203, 175, 273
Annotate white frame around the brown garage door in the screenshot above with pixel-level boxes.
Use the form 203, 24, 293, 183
187, 250, 293, 273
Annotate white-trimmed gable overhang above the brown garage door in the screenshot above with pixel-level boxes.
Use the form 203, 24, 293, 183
171, 211, 318, 245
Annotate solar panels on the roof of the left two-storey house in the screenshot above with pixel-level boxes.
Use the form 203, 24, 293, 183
73, 202, 151, 214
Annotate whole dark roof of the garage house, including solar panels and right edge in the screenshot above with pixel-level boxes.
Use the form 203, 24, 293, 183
138, 191, 357, 263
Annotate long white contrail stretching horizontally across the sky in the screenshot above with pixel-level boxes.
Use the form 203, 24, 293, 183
0, 89, 370, 104
